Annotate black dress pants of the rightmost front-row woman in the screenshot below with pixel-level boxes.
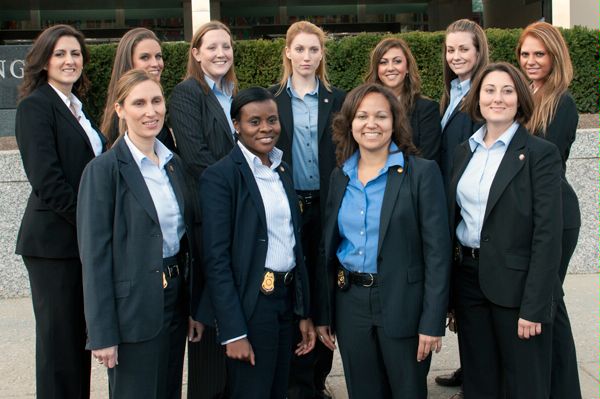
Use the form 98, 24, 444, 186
453, 257, 552, 399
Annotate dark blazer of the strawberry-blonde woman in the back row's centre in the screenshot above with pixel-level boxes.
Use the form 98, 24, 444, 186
269, 83, 346, 212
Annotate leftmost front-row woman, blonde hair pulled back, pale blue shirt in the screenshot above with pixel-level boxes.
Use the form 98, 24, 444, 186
77, 69, 196, 399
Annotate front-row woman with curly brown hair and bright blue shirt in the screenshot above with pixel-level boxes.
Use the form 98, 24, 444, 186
315, 83, 451, 399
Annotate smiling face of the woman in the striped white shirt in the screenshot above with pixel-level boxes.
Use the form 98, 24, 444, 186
233, 100, 281, 164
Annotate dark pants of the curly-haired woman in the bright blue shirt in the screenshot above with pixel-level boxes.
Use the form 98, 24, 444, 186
335, 285, 431, 399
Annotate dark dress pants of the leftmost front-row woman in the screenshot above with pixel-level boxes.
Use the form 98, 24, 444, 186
108, 270, 187, 399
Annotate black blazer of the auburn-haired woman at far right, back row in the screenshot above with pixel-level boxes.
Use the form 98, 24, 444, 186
541, 92, 581, 229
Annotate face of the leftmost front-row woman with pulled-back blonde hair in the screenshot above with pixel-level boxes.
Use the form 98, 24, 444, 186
115, 80, 166, 143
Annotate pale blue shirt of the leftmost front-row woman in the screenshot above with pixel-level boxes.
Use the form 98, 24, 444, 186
124, 133, 185, 258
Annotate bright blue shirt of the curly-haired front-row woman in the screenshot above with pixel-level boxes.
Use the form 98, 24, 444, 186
336, 142, 404, 273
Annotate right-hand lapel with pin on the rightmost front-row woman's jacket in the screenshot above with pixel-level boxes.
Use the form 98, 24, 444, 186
483, 126, 527, 223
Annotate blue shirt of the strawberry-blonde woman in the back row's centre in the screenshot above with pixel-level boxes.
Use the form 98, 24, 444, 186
286, 77, 321, 191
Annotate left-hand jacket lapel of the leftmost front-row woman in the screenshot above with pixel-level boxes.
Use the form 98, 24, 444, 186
115, 139, 160, 224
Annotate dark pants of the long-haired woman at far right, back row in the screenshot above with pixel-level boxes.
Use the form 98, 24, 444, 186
550, 228, 581, 399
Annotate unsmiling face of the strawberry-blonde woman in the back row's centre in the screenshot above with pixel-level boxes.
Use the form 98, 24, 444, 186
285, 32, 323, 78
